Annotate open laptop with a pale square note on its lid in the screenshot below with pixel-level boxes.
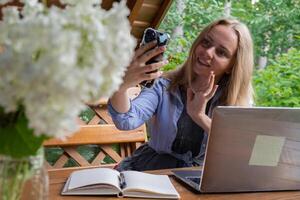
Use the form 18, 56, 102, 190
172, 106, 300, 193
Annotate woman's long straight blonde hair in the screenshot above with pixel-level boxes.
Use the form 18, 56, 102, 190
165, 19, 254, 106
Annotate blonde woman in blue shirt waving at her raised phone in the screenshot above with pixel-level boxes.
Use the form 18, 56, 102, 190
109, 19, 253, 171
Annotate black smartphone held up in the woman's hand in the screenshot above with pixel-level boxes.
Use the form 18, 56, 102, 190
140, 28, 170, 87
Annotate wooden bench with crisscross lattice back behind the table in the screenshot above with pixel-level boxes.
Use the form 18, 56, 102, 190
43, 88, 147, 169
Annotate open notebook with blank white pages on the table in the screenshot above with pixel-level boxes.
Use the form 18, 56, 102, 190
61, 168, 180, 199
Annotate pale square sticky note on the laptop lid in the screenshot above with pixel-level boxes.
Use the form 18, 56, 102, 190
249, 135, 285, 167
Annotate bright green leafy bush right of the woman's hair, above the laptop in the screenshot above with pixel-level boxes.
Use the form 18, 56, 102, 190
254, 48, 300, 107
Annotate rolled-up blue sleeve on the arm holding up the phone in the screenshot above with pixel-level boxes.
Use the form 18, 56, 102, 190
108, 80, 163, 130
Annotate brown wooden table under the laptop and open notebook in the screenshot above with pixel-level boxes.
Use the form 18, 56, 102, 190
49, 168, 300, 200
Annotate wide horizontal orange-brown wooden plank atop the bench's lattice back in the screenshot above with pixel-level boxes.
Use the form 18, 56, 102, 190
43, 124, 145, 147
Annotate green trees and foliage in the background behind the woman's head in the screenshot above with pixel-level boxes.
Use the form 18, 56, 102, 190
159, 0, 300, 107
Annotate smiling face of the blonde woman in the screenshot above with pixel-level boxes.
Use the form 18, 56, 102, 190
193, 25, 238, 81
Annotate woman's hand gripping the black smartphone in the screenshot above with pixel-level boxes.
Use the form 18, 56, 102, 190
120, 41, 168, 90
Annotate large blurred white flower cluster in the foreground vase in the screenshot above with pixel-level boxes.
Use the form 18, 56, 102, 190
0, 0, 136, 138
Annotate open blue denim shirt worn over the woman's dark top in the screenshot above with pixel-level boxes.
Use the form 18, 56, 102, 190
108, 78, 218, 163
